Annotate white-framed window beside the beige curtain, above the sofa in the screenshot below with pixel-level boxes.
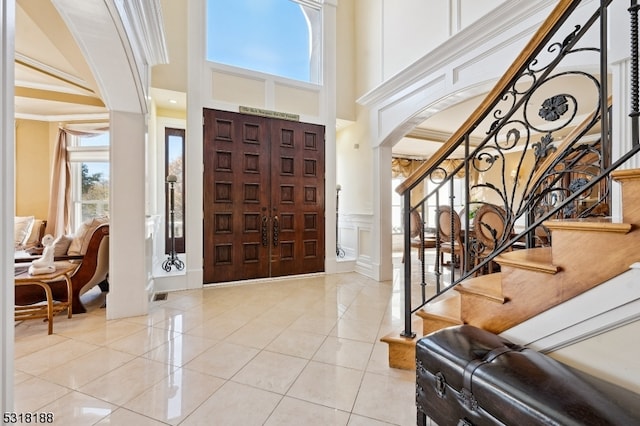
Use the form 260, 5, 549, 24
67, 132, 110, 229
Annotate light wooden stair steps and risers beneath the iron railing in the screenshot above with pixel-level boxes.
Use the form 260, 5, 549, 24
381, 169, 640, 369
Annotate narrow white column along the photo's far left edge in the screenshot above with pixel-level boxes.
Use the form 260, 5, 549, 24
0, 0, 15, 412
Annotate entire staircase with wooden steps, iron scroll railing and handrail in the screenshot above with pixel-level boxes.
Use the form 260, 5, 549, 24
381, 0, 640, 369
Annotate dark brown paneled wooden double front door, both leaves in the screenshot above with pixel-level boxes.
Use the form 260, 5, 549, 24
203, 109, 325, 283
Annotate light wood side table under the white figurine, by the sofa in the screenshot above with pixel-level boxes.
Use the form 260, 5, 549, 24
15, 262, 78, 334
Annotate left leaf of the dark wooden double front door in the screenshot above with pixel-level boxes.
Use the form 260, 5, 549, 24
203, 111, 270, 282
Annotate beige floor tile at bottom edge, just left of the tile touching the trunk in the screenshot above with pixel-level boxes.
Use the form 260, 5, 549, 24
265, 397, 349, 426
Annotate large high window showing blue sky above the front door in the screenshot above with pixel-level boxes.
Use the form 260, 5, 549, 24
206, 0, 322, 83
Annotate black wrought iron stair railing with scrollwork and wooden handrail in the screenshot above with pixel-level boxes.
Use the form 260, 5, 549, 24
396, 0, 640, 337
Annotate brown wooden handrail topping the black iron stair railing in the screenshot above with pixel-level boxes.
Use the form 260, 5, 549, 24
396, 0, 580, 195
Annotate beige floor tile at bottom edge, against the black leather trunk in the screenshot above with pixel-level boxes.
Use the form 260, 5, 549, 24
353, 373, 416, 426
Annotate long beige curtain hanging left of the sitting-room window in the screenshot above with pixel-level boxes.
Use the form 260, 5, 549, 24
45, 129, 71, 237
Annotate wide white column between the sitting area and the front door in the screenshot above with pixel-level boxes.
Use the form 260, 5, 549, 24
107, 111, 149, 319
